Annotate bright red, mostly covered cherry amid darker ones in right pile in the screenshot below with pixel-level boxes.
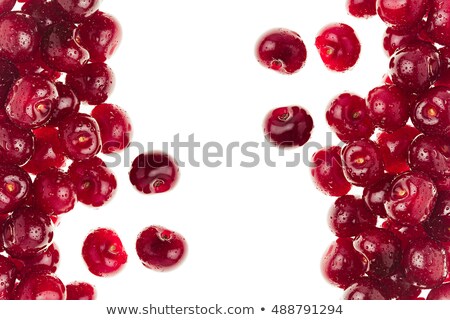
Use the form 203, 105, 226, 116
376, 125, 420, 174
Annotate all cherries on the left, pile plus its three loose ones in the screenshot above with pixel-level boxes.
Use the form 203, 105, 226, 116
0, 0, 186, 300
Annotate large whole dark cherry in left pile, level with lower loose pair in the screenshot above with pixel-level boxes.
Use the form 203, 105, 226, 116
2, 207, 53, 259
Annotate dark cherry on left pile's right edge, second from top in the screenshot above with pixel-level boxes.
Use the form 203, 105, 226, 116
66, 62, 116, 105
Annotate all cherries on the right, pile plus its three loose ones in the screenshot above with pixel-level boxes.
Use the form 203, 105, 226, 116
257, 0, 450, 300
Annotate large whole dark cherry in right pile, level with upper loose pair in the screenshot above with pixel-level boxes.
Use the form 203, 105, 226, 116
389, 41, 440, 93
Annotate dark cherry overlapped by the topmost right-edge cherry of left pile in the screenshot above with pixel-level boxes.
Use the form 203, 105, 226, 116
41, 22, 89, 72
